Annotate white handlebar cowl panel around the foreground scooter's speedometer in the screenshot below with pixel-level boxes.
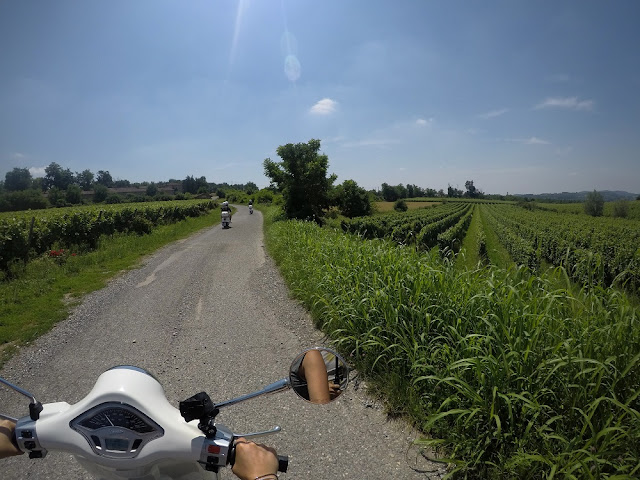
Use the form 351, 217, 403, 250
16, 367, 212, 480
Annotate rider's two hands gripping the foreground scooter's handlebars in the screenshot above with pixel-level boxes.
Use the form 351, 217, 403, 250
0, 419, 278, 480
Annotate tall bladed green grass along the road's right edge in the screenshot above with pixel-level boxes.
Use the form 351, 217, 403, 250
267, 218, 640, 479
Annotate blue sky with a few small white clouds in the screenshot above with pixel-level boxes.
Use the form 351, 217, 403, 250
0, 0, 640, 193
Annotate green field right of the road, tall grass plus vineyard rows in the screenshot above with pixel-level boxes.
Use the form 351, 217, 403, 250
267, 203, 640, 479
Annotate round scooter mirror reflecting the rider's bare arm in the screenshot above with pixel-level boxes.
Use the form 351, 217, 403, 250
289, 347, 349, 404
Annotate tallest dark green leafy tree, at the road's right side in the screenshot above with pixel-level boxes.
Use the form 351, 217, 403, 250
263, 139, 337, 223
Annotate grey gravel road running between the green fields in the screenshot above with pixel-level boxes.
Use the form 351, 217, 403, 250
0, 206, 443, 480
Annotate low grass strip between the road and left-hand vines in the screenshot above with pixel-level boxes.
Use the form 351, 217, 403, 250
0, 210, 220, 366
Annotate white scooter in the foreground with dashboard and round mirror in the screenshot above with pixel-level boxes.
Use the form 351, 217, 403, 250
0, 347, 349, 480
